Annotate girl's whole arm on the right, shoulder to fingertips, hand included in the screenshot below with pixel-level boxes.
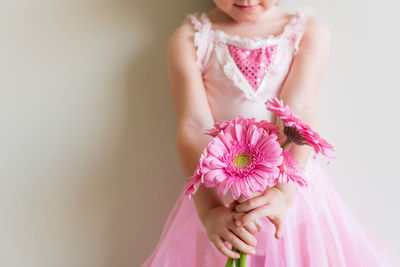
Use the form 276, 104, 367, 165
236, 17, 331, 239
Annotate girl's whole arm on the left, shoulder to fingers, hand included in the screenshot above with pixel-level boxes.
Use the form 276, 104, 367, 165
167, 19, 258, 258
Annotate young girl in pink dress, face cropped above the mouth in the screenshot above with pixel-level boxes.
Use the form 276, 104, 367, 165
142, 0, 400, 267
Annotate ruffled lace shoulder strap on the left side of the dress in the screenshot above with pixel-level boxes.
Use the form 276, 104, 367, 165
185, 13, 211, 72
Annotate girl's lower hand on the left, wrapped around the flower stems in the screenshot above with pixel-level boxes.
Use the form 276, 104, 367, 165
203, 202, 261, 258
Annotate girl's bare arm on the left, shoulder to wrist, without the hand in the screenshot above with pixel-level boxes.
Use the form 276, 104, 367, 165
167, 23, 223, 224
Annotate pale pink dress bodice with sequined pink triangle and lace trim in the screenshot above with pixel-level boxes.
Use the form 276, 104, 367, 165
186, 6, 315, 122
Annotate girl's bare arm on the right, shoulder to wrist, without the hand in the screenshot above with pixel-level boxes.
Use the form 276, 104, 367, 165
276, 17, 331, 202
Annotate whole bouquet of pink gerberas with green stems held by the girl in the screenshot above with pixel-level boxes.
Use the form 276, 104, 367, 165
184, 98, 334, 266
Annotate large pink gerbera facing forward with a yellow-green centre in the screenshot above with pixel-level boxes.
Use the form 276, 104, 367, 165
186, 116, 283, 199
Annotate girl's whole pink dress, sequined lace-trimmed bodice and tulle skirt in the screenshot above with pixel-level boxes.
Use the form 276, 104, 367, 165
142, 7, 400, 267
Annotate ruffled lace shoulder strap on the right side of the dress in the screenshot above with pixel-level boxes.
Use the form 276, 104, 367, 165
287, 6, 316, 56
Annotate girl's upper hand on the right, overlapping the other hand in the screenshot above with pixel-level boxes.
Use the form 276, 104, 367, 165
235, 186, 294, 239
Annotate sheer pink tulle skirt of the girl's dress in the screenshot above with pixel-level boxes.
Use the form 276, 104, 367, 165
142, 159, 400, 267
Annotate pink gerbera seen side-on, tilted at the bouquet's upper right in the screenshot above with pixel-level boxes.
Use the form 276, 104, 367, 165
265, 97, 335, 158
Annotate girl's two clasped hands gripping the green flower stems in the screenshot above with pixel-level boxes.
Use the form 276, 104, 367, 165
201, 185, 294, 258
